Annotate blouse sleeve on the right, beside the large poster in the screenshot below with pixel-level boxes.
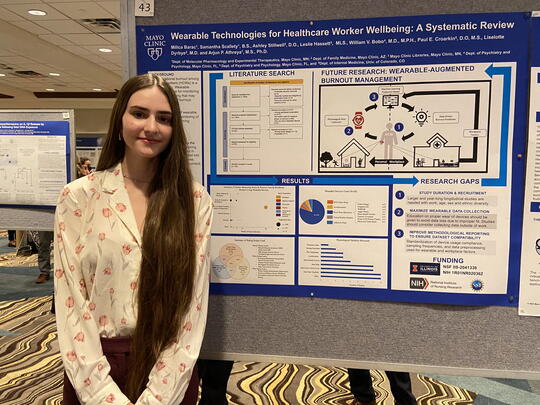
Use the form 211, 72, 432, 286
137, 184, 213, 405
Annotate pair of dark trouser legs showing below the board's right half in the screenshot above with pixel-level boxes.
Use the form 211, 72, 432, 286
348, 368, 416, 405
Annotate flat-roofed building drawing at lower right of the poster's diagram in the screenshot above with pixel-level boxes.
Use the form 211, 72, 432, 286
413, 133, 461, 167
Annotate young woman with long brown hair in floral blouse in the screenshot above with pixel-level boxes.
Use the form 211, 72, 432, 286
54, 74, 212, 405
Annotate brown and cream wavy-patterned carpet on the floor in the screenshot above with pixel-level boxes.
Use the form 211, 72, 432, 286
0, 297, 475, 405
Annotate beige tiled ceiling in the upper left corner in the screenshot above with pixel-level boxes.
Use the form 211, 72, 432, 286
0, 0, 122, 108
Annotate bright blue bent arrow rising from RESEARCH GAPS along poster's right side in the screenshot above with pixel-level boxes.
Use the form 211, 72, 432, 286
482, 64, 512, 187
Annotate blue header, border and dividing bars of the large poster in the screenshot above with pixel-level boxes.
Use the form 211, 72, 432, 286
136, 12, 538, 306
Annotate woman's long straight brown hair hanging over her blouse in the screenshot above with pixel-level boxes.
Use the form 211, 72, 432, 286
97, 74, 195, 402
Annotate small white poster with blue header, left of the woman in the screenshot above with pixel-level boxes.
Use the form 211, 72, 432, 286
0, 121, 70, 207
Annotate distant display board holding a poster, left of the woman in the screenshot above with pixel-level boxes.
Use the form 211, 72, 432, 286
0, 109, 75, 231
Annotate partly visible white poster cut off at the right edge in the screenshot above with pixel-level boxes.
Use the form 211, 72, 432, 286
519, 13, 540, 316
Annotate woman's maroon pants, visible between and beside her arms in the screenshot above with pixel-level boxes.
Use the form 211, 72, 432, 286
63, 337, 199, 405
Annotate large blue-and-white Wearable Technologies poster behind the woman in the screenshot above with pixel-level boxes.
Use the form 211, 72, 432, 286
137, 13, 530, 305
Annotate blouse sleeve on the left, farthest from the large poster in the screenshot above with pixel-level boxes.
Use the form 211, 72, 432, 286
54, 182, 129, 405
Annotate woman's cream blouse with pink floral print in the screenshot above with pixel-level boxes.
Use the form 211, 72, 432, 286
54, 165, 212, 405
